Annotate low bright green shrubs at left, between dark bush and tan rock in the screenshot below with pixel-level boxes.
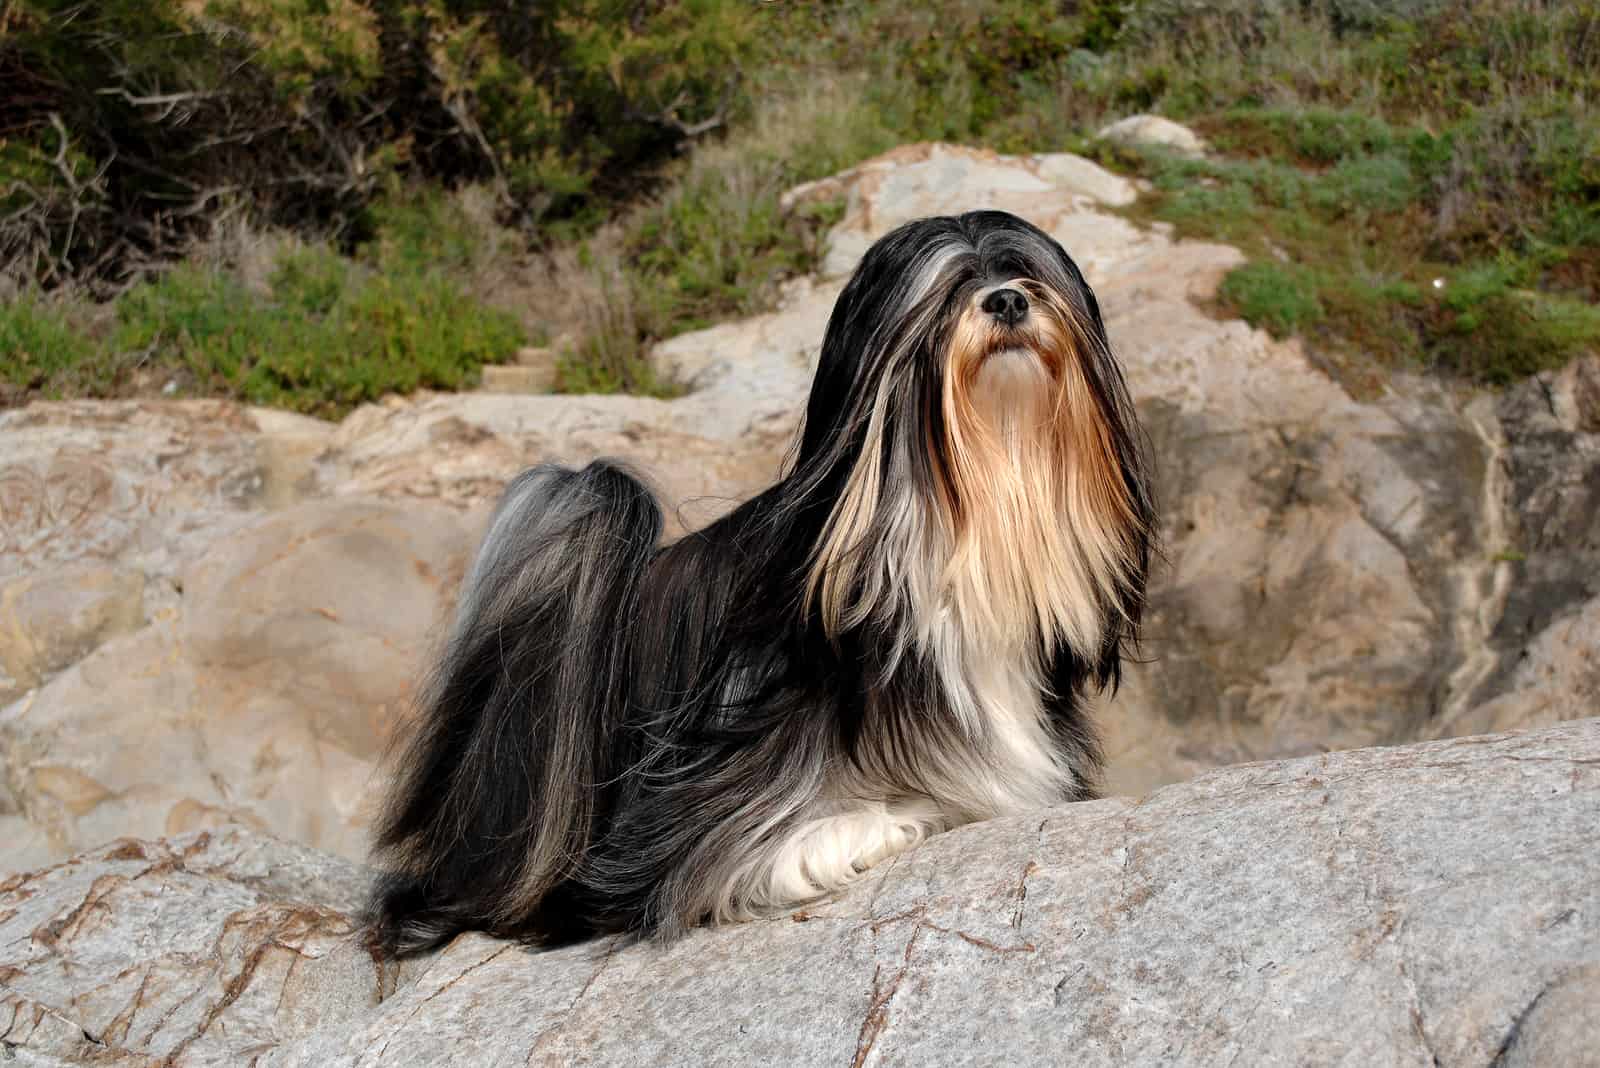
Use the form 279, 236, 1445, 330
0, 199, 523, 416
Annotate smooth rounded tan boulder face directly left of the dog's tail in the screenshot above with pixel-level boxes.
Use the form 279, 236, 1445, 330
0, 500, 477, 870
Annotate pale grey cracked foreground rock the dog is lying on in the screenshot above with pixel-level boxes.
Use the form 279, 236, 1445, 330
0, 719, 1600, 1068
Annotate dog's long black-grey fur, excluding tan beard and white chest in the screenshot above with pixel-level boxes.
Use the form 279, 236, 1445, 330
370, 213, 1154, 954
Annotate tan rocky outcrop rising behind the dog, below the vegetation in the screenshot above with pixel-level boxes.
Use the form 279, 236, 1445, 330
0, 144, 1600, 871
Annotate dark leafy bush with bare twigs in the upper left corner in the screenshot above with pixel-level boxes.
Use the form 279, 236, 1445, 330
0, 0, 752, 285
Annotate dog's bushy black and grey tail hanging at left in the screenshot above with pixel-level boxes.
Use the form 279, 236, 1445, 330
368, 462, 661, 954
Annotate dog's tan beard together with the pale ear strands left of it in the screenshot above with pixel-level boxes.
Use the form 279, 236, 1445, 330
808, 281, 1147, 667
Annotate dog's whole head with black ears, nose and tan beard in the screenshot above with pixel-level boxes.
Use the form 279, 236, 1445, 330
794, 211, 1154, 675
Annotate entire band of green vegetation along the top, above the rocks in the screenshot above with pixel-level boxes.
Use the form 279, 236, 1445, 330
0, 0, 1600, 414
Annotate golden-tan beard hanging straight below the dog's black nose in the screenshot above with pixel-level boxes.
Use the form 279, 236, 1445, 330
939, 281, 1141, 659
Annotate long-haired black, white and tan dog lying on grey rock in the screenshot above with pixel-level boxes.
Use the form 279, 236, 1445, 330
370, 211, 1154, 953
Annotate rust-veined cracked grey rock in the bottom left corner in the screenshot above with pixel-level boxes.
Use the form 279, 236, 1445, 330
0, 833, 394, 1065
